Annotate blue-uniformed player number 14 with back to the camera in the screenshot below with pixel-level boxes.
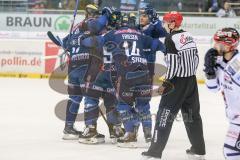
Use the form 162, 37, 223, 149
101, 14, 159, 147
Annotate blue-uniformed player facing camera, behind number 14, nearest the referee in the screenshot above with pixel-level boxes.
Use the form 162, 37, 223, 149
136, 5, 167, 142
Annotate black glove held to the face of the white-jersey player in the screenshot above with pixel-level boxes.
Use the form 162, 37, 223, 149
203, 48, 218, 79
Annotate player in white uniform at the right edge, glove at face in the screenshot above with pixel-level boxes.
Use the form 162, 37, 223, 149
204, 28, 240, 160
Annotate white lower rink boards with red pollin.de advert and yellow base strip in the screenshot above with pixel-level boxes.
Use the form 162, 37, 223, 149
0, 36, 214, 82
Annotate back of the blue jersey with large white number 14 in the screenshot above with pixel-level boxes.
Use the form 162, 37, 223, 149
105, 27, 152, 67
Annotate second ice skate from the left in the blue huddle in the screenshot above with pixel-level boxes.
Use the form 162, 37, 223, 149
78, 125, 105, 144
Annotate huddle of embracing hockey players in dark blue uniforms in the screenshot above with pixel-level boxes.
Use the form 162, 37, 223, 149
58, 5, 166, 143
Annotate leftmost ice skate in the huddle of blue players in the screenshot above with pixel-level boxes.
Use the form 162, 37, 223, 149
62, 126, 82, 140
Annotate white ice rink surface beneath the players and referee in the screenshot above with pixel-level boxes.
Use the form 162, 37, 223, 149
0, 78, 228, 160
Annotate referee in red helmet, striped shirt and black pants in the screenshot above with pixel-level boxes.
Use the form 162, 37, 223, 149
142, 12, 205, 160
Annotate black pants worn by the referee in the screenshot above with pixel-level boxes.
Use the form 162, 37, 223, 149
148, 76, 205, 158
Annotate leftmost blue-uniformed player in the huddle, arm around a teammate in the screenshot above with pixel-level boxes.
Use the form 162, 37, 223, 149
63, 4, 120, 140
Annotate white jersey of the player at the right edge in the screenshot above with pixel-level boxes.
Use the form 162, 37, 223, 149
206, 52, 240, 124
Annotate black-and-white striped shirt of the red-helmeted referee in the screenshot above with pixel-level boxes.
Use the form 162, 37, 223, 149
165, 30, 199, 79
